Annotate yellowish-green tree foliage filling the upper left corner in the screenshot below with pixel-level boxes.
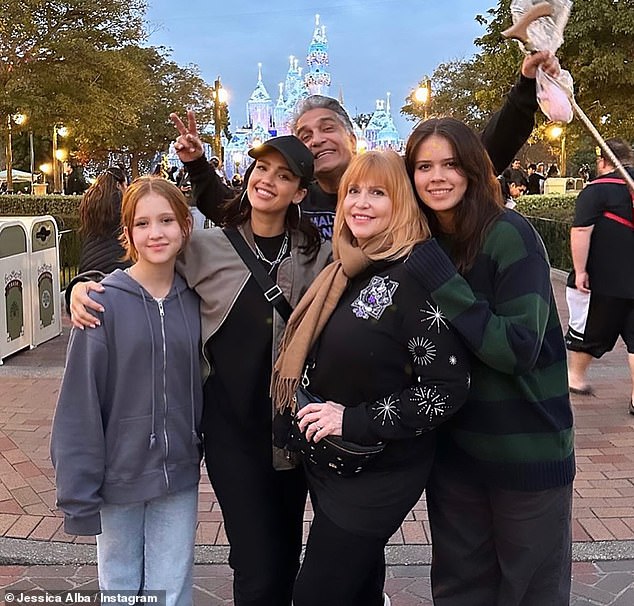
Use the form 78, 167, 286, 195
0, 0, 217, 175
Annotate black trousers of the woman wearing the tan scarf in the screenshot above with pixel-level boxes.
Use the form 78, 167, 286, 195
293, 507, 389, 606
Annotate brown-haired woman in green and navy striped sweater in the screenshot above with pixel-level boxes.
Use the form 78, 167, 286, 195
405, 118, 575, 606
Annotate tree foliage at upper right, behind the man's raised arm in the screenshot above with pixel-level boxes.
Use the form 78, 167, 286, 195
401, 0, 634, 159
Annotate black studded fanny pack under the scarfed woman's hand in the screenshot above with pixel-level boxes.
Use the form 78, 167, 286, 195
287, 387, 385, 476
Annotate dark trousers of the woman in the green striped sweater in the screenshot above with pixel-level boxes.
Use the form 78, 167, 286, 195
427, 464, 572, 606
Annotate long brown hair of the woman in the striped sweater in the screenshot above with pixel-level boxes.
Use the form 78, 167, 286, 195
405, 118, 504, 273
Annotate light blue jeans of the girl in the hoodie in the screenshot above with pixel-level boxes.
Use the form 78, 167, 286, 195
97, 486, 198, 606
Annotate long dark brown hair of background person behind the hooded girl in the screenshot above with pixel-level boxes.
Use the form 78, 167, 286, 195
79, 166, 127, 238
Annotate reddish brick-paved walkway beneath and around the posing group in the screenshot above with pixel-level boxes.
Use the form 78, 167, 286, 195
0, 272, 634, 606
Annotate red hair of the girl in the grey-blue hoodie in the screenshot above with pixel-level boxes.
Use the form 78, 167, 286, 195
119, 176, 192, 263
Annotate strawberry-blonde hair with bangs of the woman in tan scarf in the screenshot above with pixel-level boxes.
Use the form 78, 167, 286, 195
332, 150, 430, 261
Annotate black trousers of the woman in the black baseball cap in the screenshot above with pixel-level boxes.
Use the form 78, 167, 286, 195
205, 444, 307, 606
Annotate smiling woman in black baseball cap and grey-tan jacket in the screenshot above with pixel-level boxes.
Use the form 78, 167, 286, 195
71, 136, 330, 606
